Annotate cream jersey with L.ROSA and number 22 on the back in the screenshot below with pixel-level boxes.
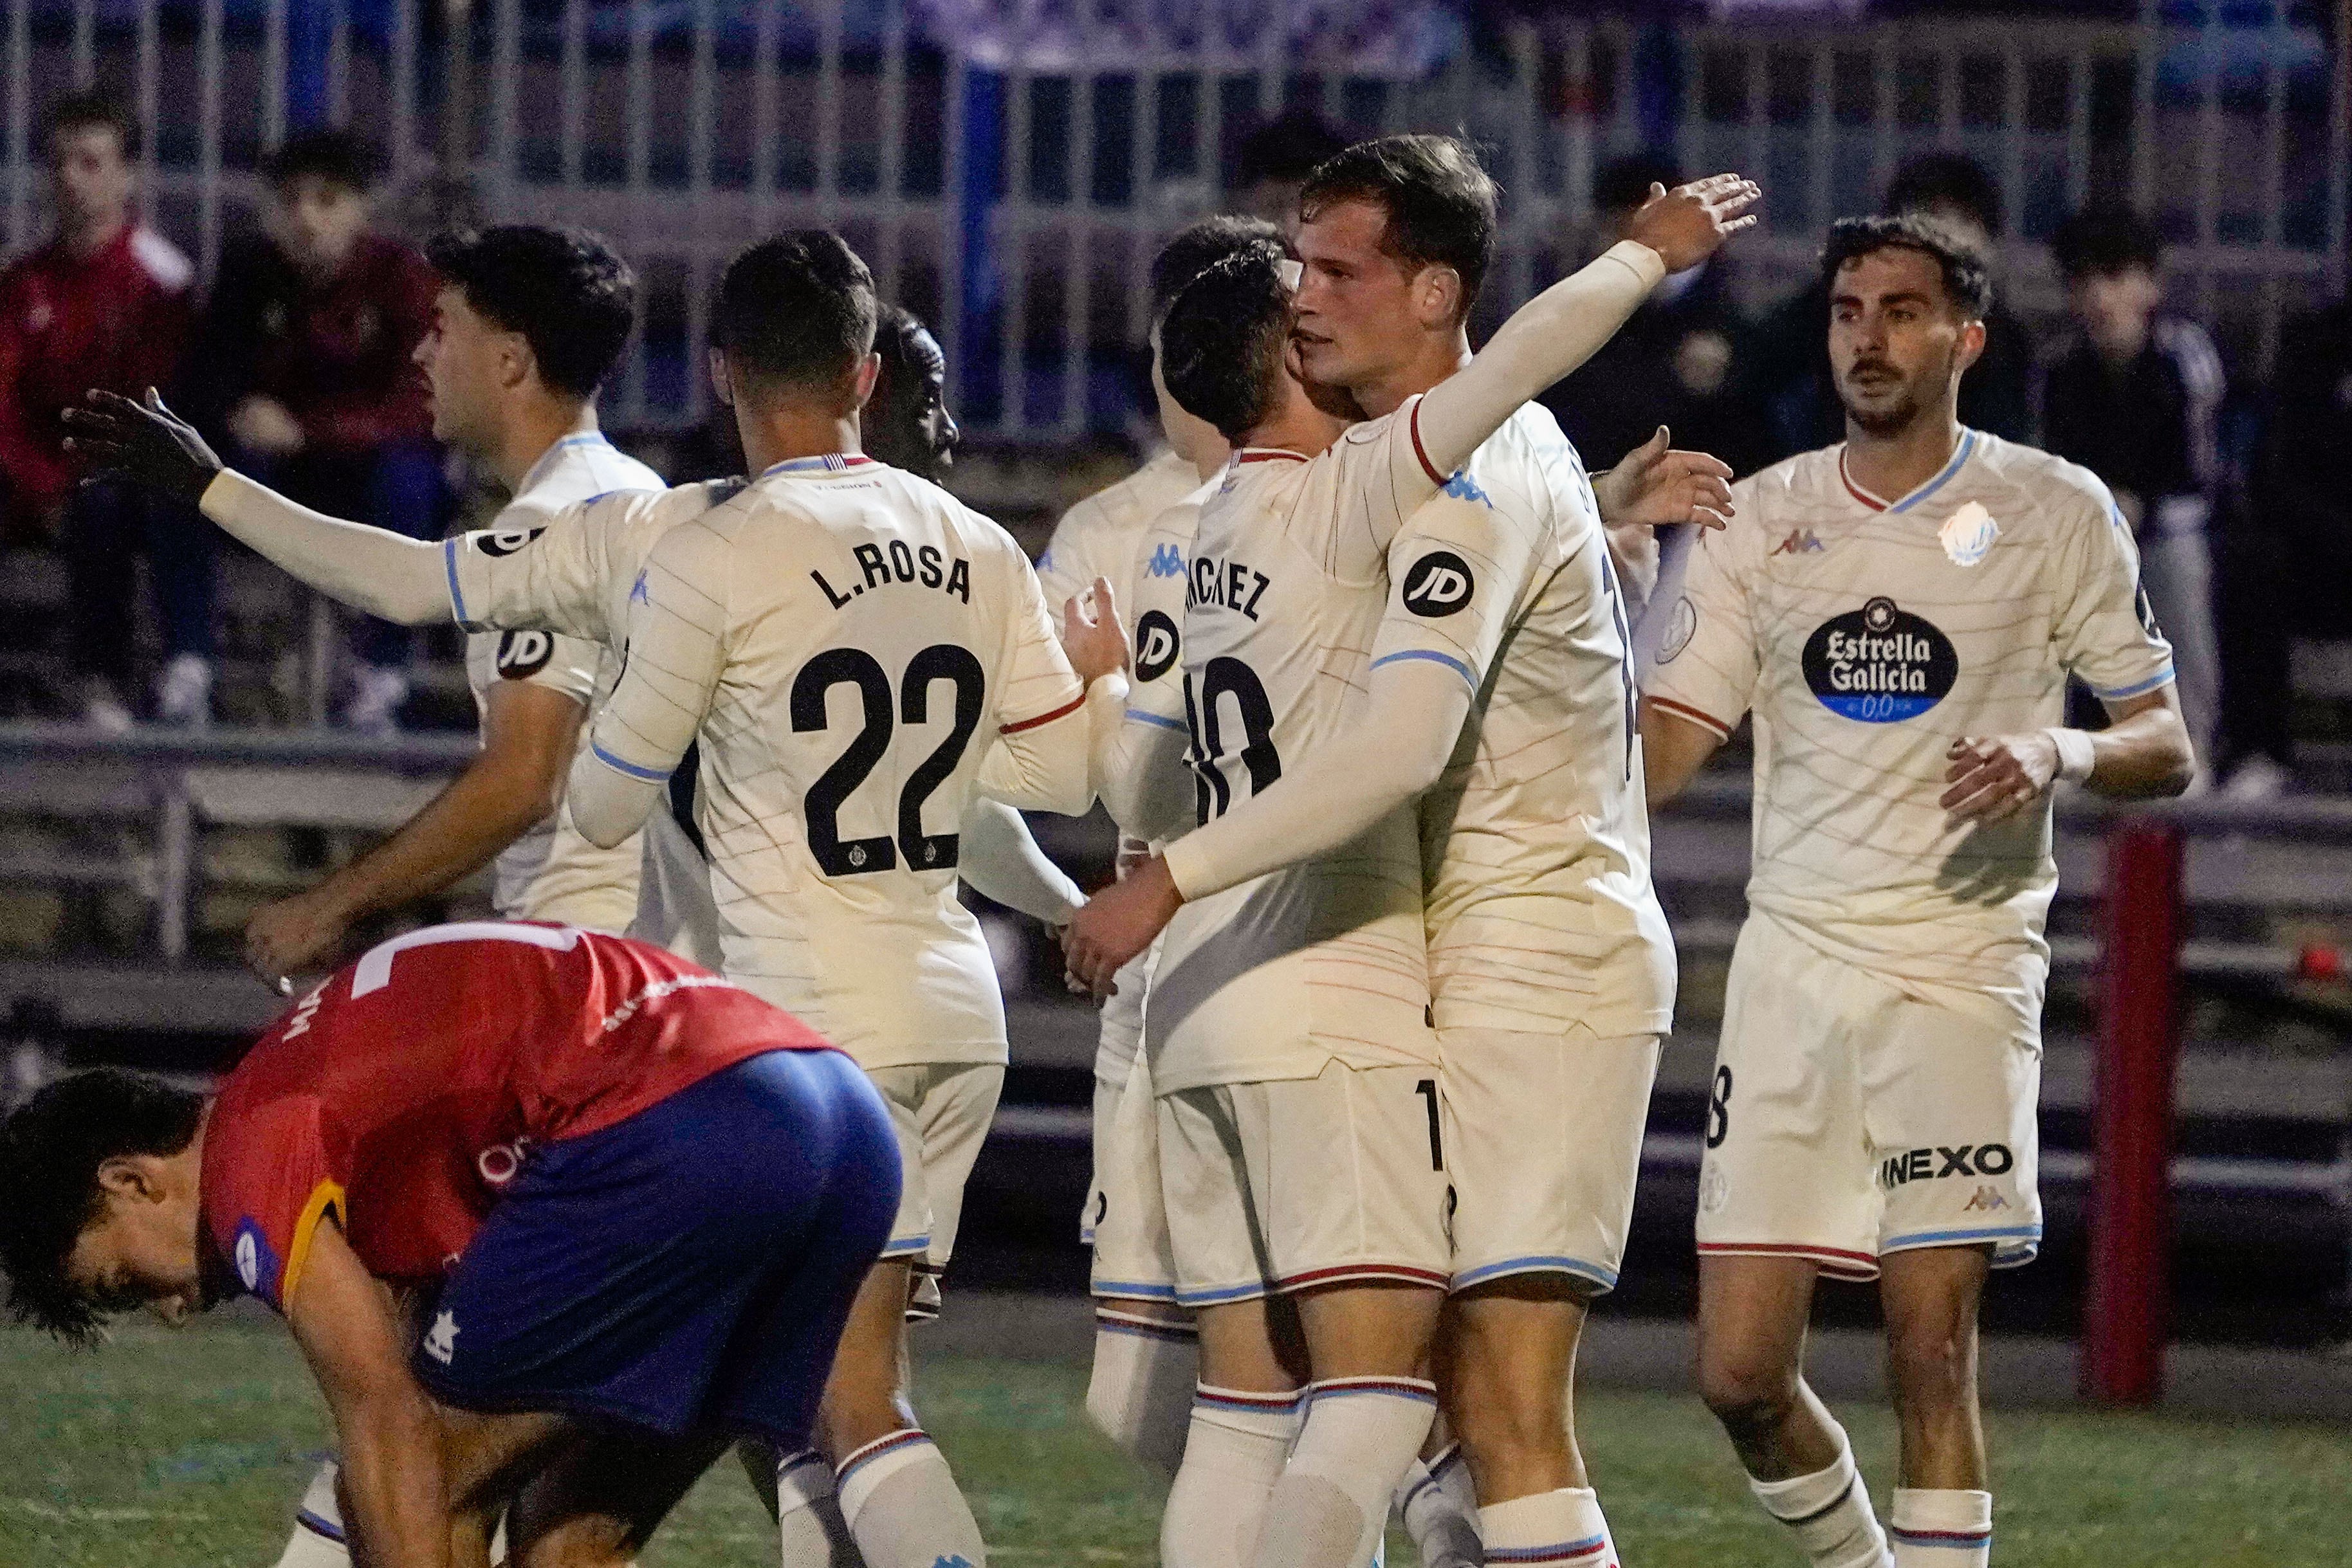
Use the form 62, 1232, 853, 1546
574, 456, 1087, 1067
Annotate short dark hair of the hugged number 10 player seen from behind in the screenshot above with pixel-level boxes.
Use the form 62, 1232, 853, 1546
1159, 242, 1291, 444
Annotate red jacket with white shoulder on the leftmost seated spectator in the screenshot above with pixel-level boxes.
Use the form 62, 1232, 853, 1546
0, 223, 195, 517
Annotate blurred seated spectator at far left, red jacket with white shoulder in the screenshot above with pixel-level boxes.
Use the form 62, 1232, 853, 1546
0, 92, 199, 733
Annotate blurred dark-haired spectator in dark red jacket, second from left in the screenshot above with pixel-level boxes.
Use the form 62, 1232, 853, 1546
188, 132, 447, 733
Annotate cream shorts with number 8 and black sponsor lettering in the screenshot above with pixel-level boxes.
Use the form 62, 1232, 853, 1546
1698, 915, 2041, 1279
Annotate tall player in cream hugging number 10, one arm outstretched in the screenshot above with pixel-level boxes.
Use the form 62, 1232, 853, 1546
1070, 136, 1754, 1563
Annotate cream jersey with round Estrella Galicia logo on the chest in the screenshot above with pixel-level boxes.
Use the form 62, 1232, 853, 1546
1649, 430, 2173, 1023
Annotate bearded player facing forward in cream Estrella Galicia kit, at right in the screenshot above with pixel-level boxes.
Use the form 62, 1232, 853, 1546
1642, 216, 2194, 1568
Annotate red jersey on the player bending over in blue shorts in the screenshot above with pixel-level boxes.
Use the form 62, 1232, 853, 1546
200, 922, 831, 1312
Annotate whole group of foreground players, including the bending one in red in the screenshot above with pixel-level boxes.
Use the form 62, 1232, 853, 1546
0, 136, 2194, 1568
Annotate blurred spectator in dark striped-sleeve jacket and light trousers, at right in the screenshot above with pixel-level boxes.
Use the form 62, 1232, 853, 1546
2041, 205, 2223, 785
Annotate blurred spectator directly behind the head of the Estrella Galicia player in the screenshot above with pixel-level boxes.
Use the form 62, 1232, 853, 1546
1761, 153, 2034, 456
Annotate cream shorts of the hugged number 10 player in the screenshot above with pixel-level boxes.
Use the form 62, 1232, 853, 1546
1159, 1062, 1451, 1307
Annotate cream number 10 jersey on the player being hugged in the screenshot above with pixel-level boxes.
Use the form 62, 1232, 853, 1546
1136, 439, 1435, 1093
